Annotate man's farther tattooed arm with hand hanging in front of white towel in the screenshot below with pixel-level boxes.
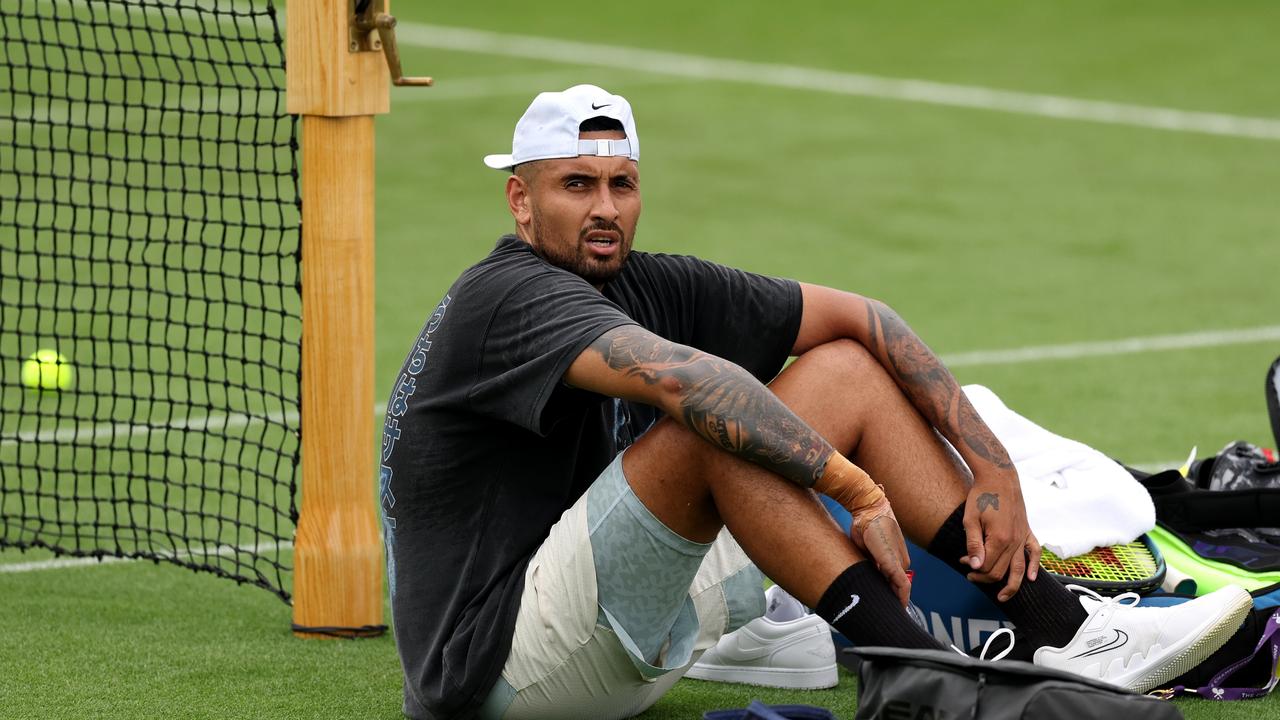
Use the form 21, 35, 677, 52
794, 284, 1041, 600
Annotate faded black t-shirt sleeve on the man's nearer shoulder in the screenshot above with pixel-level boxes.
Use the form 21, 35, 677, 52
468, 270, 635, 436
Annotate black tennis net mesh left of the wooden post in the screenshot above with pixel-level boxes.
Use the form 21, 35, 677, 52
0, 0, 302, 600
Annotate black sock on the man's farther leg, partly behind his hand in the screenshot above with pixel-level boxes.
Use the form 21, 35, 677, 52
929, 503, 1088, 660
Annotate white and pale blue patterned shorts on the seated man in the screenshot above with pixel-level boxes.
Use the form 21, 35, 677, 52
480, 454, 764, 720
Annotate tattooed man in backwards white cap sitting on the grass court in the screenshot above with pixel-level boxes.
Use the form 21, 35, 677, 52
381, 86, 1251, 719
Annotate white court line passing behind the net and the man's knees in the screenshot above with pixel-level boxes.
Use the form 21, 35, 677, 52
0, 325, 1280, 448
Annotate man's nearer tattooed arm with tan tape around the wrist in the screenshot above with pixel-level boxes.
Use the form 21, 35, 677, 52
564, 325, 910, 605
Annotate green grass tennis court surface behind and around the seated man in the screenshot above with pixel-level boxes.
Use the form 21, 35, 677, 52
0, 1, 1280, 719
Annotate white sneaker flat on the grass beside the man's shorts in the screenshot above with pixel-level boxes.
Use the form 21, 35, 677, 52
685, 585, 840, 689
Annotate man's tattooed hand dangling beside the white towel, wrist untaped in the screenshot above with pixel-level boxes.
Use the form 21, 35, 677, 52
960, 469, 1041, 602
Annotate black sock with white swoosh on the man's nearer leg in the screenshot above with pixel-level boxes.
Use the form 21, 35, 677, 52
814, 561, 942, 650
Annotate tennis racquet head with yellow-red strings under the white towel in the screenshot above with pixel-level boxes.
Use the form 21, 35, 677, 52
1041, 534, 1167, 596
